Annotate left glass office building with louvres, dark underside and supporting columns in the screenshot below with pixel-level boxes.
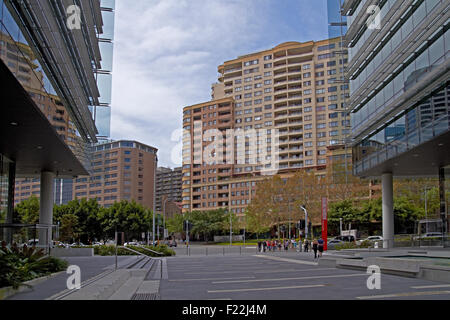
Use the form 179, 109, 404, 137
0, 0, 110, 245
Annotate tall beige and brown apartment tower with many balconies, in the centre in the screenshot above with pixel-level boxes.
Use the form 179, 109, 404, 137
182, 38, 350, 215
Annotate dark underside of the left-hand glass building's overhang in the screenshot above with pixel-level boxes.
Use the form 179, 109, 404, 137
0, 60, 88, 178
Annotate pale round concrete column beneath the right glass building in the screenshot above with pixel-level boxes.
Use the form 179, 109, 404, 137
381, 173, 394, 249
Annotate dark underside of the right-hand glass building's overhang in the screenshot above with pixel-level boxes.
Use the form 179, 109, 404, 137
358, 131, 450, 178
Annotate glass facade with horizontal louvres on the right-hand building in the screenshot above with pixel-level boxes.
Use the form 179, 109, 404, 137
346, 0, 450, 176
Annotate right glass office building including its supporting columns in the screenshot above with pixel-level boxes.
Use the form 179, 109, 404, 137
342, 0, 450, 247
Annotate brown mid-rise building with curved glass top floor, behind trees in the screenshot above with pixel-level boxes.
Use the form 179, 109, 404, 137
73, 140, 158, 209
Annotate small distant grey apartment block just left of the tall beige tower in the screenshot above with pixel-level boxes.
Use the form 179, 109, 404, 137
156, 167, 183, 212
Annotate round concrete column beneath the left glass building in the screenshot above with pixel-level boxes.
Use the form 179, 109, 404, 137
39, 171, 55, 246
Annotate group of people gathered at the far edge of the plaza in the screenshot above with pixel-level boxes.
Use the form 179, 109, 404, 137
258, 238, 324, 259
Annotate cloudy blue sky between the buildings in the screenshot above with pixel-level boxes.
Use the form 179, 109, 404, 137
111, 0, 328, 168
